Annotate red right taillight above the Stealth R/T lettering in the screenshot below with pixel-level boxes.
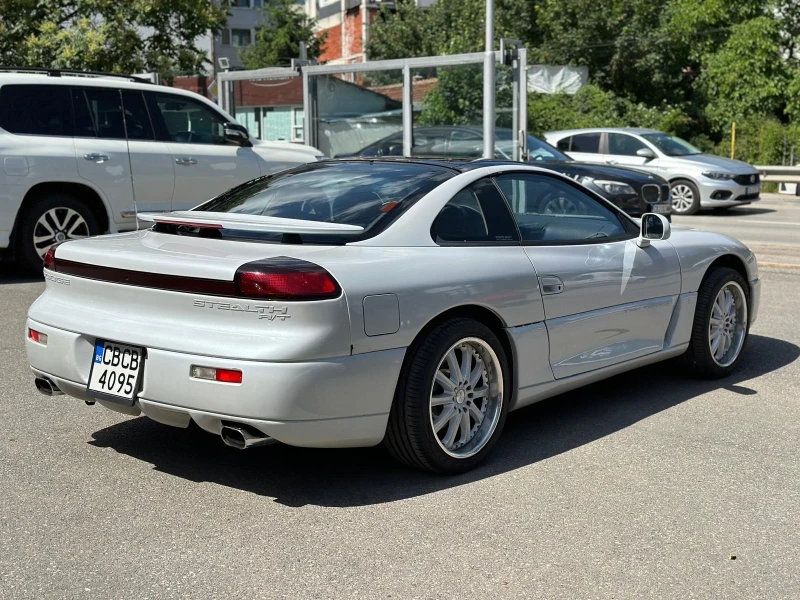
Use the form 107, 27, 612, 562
235, 257, 342, 300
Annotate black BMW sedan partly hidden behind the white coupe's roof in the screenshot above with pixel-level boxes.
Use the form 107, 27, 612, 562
336, 126, 671, 218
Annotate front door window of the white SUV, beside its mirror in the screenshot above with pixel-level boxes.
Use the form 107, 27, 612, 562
155, 93, 225, 144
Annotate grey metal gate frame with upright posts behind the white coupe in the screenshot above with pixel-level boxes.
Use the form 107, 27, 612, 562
217, 50, 528, 160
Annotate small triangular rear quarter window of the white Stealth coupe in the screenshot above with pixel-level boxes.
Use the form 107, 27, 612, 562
431, 179, 519, 244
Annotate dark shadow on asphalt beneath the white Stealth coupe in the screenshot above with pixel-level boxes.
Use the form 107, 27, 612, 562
89, 335, 800, 507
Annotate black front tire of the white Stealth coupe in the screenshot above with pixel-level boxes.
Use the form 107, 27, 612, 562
684, 267, 750, 379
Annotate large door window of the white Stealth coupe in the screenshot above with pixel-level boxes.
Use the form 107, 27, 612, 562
496, 173, 630, 245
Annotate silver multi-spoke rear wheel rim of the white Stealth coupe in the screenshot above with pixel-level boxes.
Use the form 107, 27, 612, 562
430, 338, 504, 458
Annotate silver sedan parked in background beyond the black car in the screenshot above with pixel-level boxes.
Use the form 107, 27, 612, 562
545, 127, 761, 215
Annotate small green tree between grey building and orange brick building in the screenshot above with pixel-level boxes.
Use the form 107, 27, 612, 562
239, 0, 326, 69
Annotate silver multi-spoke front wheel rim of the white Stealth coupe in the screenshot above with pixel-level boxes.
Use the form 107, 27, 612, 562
708, 281, 747, 367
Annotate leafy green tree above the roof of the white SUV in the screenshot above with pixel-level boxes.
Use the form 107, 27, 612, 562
0, 0, 227, 75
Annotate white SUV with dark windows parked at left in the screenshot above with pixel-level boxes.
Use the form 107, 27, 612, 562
0, 70, 322, 269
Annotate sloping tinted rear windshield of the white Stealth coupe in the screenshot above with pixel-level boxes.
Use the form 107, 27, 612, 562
194, 162, 455, 239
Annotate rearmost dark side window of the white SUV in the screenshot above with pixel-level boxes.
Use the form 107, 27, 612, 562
0, 85, 72, 136
